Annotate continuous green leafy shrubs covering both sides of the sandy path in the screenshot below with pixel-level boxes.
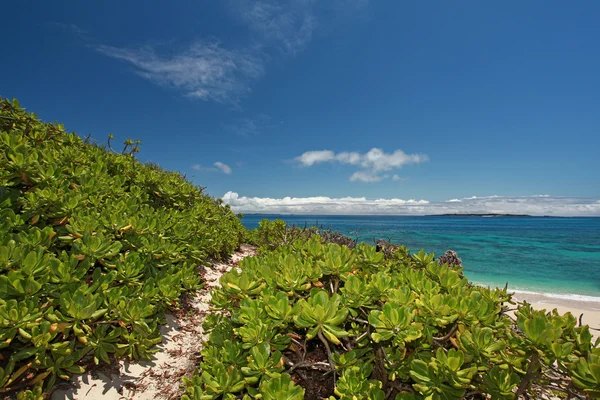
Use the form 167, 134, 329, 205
0, 99, 600, 400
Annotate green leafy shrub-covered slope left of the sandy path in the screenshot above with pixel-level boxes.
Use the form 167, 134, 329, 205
0, 99, 244, 399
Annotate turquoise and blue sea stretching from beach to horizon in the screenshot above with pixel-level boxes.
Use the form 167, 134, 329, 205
243, 215, 600, 301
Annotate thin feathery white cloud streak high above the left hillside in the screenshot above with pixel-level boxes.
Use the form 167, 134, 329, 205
96, 42, 264, 103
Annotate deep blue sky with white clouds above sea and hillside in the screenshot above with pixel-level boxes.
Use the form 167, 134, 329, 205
0, 0, 600, 215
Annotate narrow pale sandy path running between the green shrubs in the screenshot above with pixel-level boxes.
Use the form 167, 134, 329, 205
51, 245, 255, 400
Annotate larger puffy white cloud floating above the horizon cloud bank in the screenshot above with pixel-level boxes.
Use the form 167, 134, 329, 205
295, 148, 429, 183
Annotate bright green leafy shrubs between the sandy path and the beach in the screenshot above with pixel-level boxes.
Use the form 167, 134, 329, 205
184, 221, 600, 400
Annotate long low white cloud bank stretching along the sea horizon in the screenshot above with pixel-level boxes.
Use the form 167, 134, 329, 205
223, 192, 600, 217
